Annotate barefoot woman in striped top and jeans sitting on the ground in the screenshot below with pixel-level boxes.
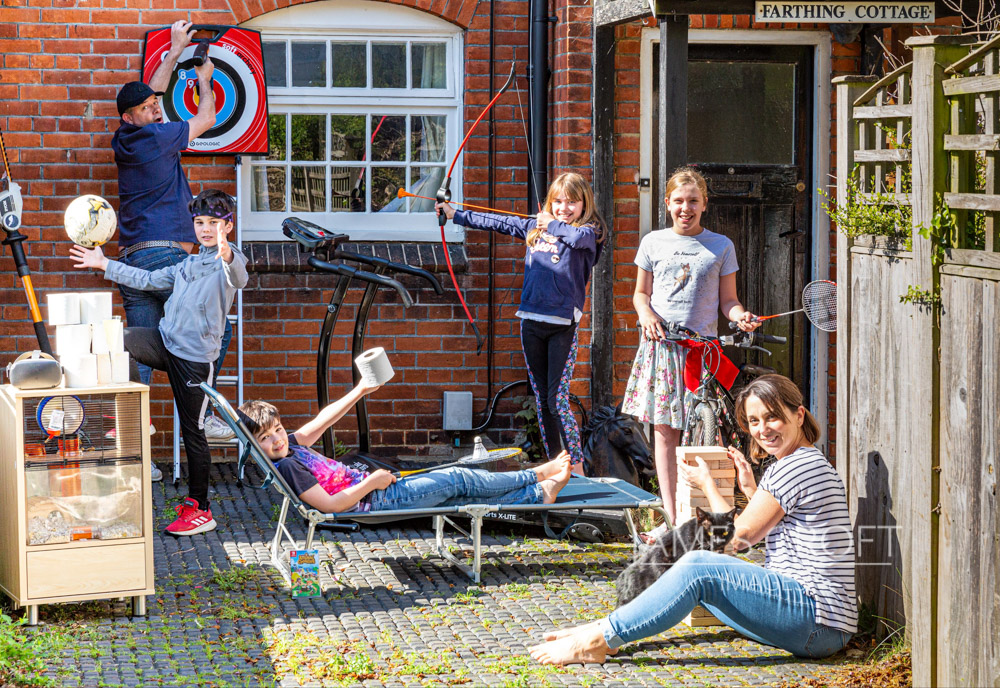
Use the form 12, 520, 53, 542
531, 375, 858, 664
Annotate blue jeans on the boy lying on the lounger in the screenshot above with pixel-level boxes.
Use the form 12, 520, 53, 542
369, 466, 544, 511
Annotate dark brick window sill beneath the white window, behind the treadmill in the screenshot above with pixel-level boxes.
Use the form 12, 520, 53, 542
242, 241, 469, 274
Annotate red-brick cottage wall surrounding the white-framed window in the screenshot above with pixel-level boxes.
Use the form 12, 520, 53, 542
0, 0, 548, 462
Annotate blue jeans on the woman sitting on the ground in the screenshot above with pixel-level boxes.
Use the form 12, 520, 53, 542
602, 550, 852, 659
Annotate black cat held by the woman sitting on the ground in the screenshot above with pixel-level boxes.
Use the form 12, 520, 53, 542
615, 507, 742, 607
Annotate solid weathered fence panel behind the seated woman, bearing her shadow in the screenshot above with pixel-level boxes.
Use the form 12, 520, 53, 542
848, 247, 925, 627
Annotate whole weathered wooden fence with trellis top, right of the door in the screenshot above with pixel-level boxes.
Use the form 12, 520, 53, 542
835, 37, 1000, 686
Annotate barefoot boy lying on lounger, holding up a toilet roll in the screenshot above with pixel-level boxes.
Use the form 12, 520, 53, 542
239, 382, 570, 513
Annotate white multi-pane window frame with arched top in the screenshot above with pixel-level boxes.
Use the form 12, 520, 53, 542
238, 0, 465, 241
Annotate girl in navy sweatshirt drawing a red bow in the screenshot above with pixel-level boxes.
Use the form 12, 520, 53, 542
434, 172, 607, 475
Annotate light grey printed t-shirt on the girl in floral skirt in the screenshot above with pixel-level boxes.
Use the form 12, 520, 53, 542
635, 229, 740, 335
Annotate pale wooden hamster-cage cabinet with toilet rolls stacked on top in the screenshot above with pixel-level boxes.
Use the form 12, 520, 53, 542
0, 383, 153, 623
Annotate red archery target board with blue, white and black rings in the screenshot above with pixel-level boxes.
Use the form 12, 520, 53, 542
142, 26, 268, 155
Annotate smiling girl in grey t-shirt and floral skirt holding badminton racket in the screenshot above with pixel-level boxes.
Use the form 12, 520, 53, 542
622, 168, 758, 537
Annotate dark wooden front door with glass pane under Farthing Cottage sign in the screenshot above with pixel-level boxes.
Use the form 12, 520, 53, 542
652, 44, 812, 398
